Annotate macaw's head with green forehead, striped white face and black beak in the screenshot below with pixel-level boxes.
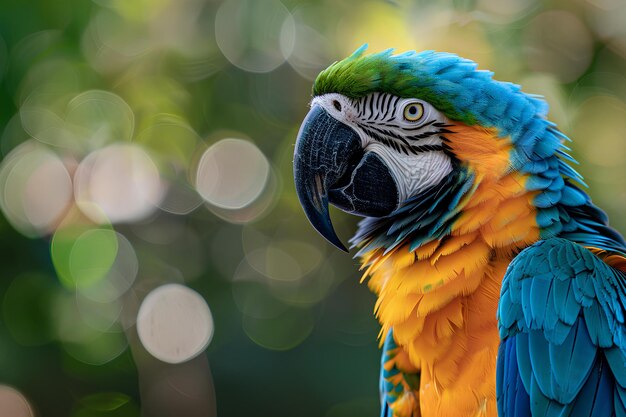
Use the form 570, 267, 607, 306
294, 46, 562, 250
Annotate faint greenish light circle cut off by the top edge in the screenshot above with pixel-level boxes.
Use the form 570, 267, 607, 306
215, 0, 295, 72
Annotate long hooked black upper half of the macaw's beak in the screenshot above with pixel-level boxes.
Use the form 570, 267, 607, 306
293, 105, 363, 252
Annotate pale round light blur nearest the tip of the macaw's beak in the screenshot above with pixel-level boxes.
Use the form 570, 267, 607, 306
196, 139, 270, 210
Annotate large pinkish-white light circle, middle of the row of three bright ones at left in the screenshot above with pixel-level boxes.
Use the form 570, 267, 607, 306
74, 144, 166, 223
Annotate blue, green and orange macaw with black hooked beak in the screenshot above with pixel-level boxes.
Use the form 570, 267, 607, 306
293, 45, 626, 417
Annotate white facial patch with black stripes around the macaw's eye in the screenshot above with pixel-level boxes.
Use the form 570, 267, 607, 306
311, 93, 452, 202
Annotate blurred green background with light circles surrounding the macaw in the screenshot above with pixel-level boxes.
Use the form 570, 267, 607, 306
0, 0, 626, 417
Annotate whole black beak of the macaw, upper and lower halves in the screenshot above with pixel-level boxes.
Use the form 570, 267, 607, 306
293, 105, 398, 252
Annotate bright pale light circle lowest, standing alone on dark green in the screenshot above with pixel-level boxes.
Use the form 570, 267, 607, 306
137, 284, 214, 363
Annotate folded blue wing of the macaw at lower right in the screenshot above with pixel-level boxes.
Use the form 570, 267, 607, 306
497, 237, 626, 417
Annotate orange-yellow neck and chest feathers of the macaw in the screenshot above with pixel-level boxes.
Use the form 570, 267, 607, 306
364, 167, 539, 417
